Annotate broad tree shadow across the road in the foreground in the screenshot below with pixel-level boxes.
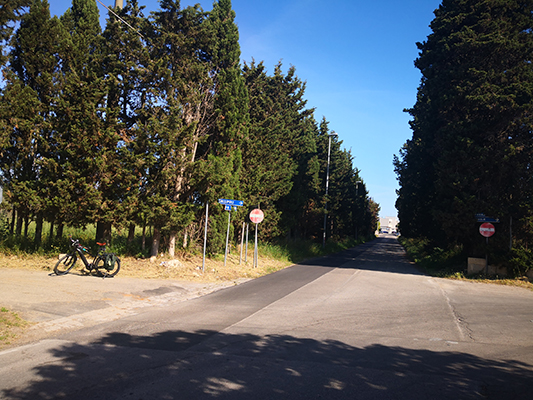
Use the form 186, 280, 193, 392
0, 330, 533, 400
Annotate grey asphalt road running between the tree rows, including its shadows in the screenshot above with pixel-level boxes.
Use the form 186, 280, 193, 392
0, 237, 533, 400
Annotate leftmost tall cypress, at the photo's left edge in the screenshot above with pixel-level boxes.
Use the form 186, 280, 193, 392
3, 0, 64, 244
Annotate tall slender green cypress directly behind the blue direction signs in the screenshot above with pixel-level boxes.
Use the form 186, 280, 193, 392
195, 0, 248, 252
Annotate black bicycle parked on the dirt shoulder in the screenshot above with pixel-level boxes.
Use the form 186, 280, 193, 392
54, 238, 120, 278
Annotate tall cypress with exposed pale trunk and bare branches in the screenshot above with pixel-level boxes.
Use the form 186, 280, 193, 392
148, 0, 214, 256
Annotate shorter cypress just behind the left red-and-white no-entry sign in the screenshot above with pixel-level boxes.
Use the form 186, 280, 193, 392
241, 62, 312, 238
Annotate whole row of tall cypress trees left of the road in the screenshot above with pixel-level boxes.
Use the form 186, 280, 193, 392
0, 0, 379, 255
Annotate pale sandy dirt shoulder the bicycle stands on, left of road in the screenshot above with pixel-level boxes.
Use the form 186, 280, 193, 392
0, 254, 290, 349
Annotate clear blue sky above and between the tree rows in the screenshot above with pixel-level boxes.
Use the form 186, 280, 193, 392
49, 0, 441, 216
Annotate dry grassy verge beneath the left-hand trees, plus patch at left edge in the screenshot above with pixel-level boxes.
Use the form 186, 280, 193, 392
0, 229, 373, 349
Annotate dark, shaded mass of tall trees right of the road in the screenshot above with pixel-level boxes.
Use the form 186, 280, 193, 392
394, 0, 533, 262
